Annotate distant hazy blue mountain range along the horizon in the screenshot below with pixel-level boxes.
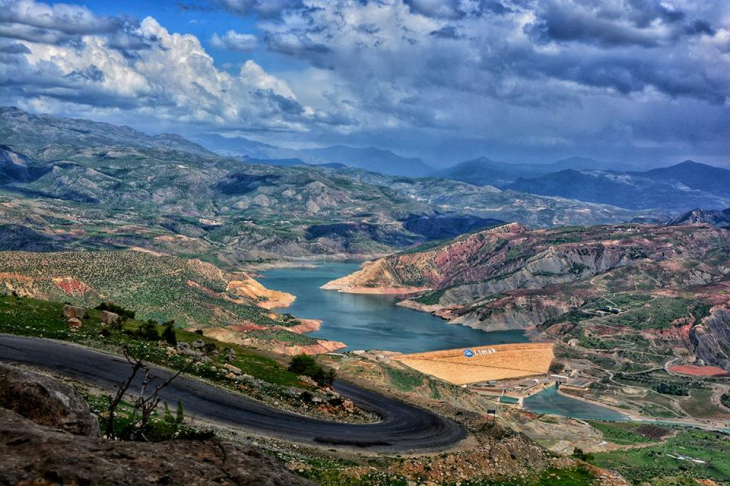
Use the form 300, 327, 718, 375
192, 131, 730, 214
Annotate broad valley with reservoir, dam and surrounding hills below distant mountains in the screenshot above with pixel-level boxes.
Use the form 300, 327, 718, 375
0, 108, 730, 486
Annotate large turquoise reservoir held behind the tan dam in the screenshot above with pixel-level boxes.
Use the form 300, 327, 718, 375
260, 262, 527, 353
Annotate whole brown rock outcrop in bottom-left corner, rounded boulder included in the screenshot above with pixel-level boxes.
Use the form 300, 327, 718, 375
0, 364, 314, 486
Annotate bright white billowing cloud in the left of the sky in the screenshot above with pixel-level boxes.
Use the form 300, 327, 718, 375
0, 1, 344, 130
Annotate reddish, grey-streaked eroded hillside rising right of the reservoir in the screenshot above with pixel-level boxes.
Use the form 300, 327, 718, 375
324, 224, 730, 366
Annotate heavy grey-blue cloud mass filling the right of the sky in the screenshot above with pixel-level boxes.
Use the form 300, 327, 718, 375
225, 0, 730, 159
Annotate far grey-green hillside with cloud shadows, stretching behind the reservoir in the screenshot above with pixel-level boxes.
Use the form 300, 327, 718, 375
0, 109, 641, 266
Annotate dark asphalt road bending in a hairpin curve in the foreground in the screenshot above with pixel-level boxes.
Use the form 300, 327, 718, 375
0, 334, 466, 452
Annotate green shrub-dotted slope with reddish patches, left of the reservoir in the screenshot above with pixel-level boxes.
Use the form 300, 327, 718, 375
0, 251, 304, 327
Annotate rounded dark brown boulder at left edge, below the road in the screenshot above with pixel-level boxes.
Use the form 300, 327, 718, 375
0, 364, 99, 436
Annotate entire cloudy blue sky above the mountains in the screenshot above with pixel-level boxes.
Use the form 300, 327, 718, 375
0, 0, 730, 166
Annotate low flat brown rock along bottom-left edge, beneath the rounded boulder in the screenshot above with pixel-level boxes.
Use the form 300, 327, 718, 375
0, 409, 312, 486
